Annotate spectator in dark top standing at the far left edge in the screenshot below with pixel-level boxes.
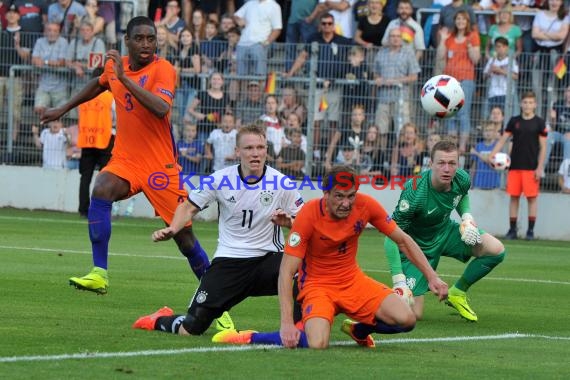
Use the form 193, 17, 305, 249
0, 4, 32, 141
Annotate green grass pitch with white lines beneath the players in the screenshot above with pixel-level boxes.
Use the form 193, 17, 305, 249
0, 209, 570, 380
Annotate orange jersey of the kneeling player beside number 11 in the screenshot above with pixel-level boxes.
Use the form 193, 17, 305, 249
285, 193, 397, 289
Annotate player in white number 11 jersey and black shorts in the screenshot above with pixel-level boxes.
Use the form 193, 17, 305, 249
133, 125, 303, 335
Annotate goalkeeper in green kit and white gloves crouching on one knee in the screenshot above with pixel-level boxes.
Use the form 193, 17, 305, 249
385, 140, 505, 322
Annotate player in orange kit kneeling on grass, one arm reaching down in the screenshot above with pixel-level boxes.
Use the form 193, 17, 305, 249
212, 166, 447, 348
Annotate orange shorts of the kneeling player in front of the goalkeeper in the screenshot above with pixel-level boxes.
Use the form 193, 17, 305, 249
299, 273, 394, 325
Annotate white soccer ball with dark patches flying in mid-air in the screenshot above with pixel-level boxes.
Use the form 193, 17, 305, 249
420, 75, 465, 118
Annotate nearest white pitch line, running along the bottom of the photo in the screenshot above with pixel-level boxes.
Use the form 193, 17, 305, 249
0, 333, 570, 363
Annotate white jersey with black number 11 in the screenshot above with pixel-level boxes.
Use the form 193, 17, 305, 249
188, 165, 303, 258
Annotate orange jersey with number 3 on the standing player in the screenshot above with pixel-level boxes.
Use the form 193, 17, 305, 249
99, 57, 176, 168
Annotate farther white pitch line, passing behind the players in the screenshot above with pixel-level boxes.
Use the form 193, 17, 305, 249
0, 245, 570, 285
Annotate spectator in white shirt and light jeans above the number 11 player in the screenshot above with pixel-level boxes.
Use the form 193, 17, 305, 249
234, 0, 283, 83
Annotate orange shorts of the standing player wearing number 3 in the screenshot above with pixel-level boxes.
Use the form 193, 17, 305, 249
102, 157, 192, 226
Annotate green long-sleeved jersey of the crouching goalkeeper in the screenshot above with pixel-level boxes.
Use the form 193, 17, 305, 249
392, 169, 471, 258
